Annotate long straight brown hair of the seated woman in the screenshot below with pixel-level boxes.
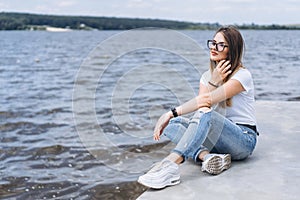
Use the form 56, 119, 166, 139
210, 26, 244, 106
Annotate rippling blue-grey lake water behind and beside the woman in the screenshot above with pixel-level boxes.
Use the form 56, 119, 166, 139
0, 30, 300, 199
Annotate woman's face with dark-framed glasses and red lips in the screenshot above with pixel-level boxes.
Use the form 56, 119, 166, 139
210, 32, 229, 62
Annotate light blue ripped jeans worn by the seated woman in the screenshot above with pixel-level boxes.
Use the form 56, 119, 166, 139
163, 110, 256, 162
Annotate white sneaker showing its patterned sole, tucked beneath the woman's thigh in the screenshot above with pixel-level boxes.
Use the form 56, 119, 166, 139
201, 154, 231, 175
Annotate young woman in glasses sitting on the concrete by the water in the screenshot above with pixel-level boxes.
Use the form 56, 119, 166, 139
138, 26, 257, 189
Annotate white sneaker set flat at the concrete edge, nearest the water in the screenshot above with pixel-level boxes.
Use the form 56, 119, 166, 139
138, 159, 180, 189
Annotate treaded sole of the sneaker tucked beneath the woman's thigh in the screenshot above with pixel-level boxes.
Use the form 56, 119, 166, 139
202, 154, 231, 175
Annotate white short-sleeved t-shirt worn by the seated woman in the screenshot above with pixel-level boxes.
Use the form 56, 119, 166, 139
200, 68, 256, 125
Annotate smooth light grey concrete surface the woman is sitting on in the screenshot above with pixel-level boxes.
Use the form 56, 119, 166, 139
138, 101, 300, 200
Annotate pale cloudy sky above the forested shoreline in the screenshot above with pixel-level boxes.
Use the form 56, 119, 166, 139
0, 0, 300, 25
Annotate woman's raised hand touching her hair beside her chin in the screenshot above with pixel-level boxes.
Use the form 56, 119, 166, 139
210, 60, 232, 85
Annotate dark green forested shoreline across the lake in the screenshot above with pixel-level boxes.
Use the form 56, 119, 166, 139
0, 12, 300, 30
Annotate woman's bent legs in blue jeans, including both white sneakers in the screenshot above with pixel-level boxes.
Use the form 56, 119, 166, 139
138, 108, 256, 188
